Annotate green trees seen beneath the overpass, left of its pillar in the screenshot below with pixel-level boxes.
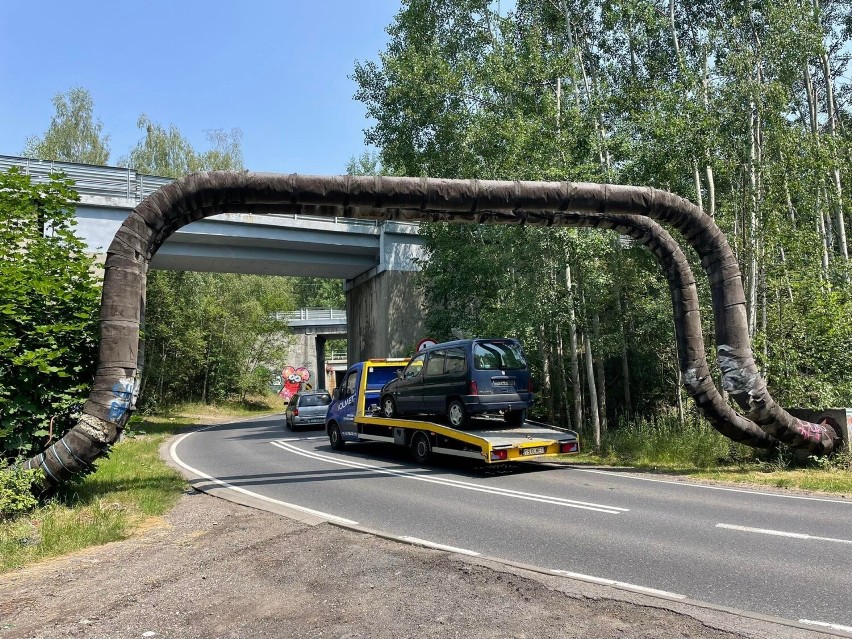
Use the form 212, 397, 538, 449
141, 271, 293, 410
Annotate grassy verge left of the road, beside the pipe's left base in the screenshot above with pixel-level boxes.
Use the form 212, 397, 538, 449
0, 399, 283, 573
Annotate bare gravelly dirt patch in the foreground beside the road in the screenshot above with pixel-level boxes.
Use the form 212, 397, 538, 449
0, 492, 818, 639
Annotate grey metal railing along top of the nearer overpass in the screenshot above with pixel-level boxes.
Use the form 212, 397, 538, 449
0, 155, 381, 226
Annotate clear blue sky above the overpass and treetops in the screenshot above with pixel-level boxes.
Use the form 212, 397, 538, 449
0, 0, 400, 174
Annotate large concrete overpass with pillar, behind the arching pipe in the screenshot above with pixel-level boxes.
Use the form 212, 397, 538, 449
0, 156, 424, 361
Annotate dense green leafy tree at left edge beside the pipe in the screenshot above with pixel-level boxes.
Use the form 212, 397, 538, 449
0, 169, 100, 457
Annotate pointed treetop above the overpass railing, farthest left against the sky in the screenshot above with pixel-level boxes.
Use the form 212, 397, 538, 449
23, 87, 109, 165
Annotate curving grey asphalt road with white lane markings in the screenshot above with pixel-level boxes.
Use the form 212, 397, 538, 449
172, 416, 852, 632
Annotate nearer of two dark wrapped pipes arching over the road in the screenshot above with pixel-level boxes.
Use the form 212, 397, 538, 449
26, 171, 837, 485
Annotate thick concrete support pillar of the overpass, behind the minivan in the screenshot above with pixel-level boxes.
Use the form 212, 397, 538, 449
345, 269, 426, 364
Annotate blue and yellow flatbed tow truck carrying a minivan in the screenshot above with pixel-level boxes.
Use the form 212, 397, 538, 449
325, 358, 580, 464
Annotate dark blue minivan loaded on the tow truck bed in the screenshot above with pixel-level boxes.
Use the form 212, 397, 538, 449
380, 338, 533, 428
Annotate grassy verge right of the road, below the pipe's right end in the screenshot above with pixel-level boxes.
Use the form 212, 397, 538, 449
565, 418, 852, 496
